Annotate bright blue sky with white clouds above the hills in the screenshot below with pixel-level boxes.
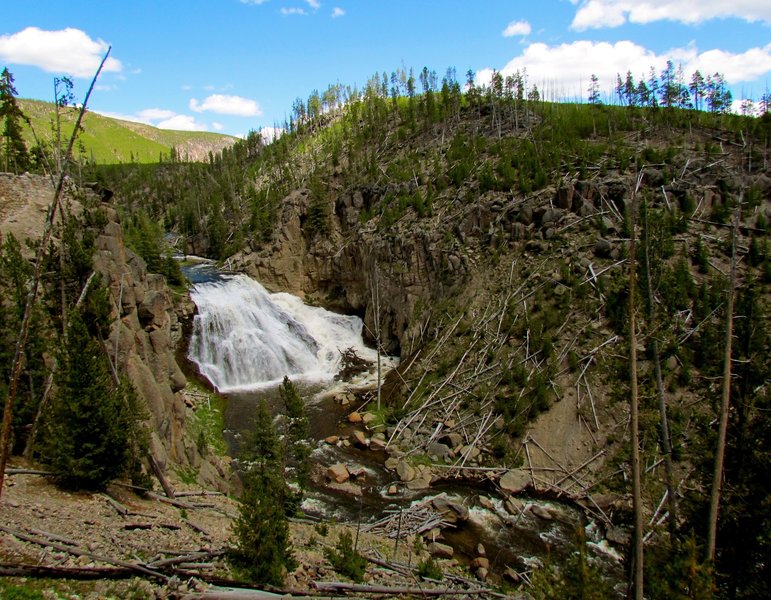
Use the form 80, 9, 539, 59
0, 0, 771, 135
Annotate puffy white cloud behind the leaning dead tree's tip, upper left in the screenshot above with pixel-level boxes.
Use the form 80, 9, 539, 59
0, 27, 123, 78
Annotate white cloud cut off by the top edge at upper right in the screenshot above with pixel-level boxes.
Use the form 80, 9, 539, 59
571, 0, 771, 31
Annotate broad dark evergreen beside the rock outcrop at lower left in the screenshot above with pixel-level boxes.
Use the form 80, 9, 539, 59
43, 311, 132, 490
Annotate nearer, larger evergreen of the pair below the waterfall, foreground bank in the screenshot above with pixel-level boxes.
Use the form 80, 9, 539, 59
229, 400, 295, 585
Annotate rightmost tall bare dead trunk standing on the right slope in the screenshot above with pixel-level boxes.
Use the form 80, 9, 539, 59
707, 208, 740, 562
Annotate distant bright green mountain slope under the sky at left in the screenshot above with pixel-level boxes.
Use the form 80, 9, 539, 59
19, 99, 236, 164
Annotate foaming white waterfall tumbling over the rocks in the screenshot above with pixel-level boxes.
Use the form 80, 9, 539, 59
189, 275, 377, 392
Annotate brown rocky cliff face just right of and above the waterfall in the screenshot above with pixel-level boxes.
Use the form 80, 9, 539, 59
229, 189, 472, 355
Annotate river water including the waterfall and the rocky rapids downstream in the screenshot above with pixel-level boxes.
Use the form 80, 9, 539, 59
185, 265, 621, 575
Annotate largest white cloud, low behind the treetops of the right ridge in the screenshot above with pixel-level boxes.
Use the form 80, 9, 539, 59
476, 40, 771, 98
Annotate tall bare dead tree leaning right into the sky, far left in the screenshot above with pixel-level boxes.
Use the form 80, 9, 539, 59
0, 47, 112, 496
